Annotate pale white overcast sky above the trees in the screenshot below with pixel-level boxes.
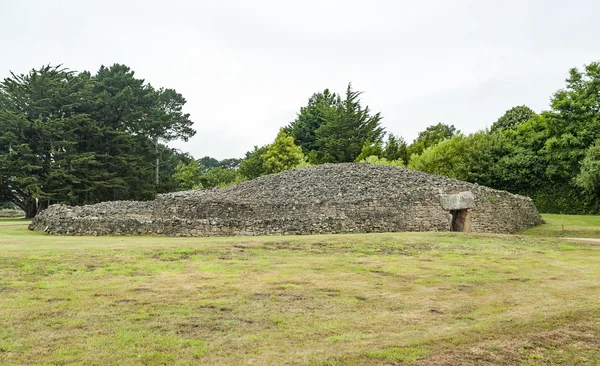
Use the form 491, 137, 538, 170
0, 0, 600, 159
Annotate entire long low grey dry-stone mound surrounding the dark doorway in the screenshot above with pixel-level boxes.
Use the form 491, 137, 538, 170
30, 163, 543, 236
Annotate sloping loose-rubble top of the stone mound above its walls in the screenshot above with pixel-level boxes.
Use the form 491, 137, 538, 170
167, 163, 466, 204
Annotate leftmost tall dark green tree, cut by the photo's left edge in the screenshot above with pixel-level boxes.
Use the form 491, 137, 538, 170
0, 66, 97, 218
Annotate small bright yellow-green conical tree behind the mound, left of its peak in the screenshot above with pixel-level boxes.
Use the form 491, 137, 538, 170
263, 128, 306, 174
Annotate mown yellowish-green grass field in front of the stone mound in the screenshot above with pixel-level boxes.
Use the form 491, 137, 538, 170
0, 215, 600, 365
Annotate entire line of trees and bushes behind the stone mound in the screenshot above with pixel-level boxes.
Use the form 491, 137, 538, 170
0, 62, 600, 215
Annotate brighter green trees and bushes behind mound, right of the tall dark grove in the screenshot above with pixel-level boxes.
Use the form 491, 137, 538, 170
173, 62, 600, 214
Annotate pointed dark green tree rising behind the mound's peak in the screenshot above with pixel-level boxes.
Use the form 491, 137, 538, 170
315, 84, 385, 163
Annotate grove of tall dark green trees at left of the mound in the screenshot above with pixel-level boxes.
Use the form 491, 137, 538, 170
0, 65, 196, 217
